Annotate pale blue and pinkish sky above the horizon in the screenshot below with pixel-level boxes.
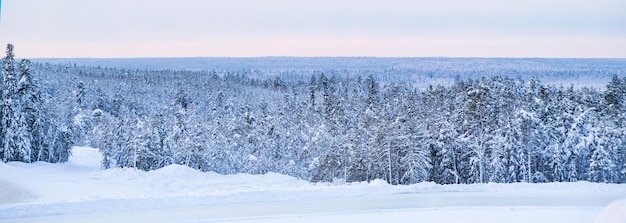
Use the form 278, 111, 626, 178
0, 0, 626, 58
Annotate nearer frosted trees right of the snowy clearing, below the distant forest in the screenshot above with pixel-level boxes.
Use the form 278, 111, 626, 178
63, 66, 626, 184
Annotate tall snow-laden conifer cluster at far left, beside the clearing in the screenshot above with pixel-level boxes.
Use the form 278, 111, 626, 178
0, 44, 72, 163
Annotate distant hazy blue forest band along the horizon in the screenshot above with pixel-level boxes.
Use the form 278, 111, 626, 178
35, 57, 626, 89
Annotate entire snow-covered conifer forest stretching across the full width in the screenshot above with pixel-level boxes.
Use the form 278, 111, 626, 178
0, 45, 626, 184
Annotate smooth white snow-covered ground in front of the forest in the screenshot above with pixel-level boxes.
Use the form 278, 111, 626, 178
0, 147, 626, 222
